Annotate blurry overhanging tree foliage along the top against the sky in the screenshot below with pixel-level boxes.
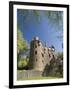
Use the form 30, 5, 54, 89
19, 9, 63, 26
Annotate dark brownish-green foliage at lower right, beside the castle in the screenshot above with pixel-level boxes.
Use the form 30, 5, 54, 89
43, 53, 63, 77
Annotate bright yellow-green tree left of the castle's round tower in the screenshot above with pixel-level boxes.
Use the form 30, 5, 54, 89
17, 29, 28, 68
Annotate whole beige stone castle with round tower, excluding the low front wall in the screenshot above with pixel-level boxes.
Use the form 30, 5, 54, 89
29, 37, 54, 71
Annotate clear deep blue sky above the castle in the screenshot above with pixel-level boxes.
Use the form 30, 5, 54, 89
17, 9, 63, 52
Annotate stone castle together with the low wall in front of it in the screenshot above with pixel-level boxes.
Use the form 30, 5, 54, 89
17, 37, 55, 79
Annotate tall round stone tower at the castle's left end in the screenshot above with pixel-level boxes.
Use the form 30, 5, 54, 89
29, 37, 44, 71
